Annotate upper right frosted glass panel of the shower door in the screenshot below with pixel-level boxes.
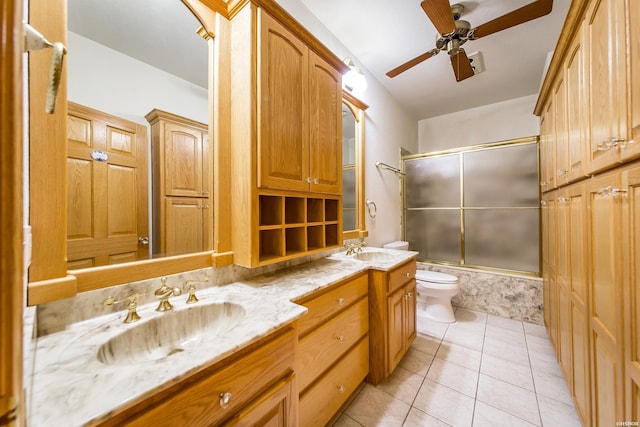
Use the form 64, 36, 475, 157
463, 144, 539, 207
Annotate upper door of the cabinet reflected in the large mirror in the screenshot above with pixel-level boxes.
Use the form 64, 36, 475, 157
164, 123, 204, 197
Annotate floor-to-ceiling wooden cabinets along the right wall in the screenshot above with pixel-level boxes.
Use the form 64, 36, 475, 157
535, 0, 640, 426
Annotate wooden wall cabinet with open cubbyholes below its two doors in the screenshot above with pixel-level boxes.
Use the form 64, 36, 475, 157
228, 2, 344, 267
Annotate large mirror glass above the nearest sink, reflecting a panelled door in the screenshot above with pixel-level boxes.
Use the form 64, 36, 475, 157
67, 0, 212, 270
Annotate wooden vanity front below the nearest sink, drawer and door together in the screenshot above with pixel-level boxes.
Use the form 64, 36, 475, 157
101, 327, 298, 427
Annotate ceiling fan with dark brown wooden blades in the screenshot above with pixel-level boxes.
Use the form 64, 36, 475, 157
387, 0, 553, 82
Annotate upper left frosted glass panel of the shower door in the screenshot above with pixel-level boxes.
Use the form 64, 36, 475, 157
405, 154, 460, 208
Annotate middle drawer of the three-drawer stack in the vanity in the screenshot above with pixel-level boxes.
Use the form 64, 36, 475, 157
296, 298, 369, 391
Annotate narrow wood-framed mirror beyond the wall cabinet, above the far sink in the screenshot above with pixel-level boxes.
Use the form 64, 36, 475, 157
342, 91, 369, 239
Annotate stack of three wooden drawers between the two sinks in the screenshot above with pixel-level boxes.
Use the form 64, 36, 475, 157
296, 274, 369, 427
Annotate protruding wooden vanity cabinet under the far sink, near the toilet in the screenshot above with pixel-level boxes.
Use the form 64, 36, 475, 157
367, 258, 417, 385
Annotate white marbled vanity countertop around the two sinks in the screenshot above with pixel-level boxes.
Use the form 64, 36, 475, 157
28, 248, 417, 426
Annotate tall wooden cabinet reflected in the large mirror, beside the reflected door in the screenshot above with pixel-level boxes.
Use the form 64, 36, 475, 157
145, 109, 212, 255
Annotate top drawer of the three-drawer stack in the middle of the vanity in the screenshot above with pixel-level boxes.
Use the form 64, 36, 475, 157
296, 274, 369, 337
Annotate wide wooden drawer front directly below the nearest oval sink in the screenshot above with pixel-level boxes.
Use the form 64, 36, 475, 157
125, 329, 296, 427
